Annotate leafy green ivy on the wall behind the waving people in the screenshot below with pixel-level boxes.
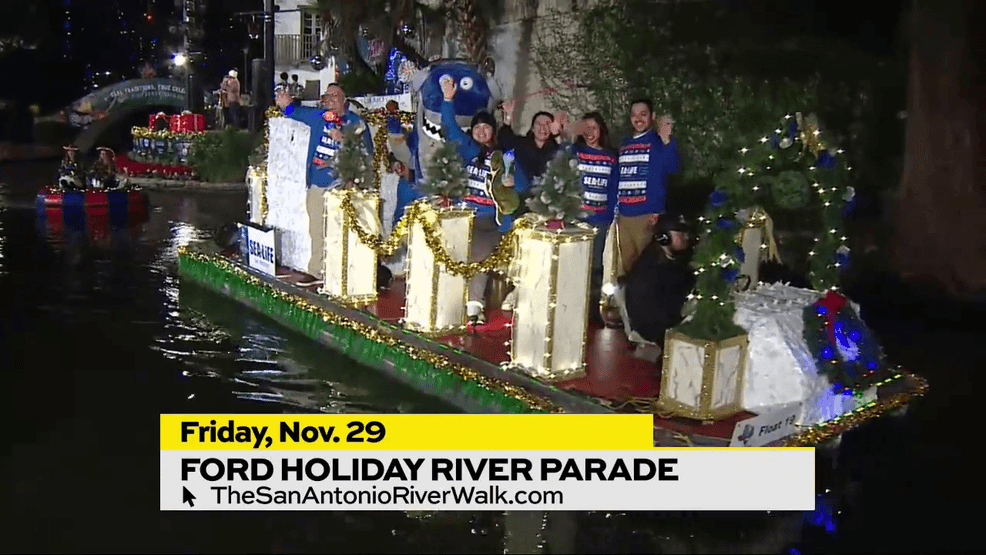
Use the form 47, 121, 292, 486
534, 0, 902, 208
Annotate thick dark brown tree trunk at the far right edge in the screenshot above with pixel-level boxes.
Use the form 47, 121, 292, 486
891, 0, 986, 294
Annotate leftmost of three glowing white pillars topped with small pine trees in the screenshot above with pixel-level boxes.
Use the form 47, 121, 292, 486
319, 188, 383, 305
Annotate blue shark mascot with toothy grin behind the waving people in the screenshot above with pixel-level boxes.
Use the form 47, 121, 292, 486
408, 60, 500, 185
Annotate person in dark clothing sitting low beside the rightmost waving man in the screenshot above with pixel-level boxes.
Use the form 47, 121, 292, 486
617, 214, 695, 362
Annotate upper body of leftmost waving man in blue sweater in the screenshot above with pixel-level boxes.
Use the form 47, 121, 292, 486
276, 83, 373, 188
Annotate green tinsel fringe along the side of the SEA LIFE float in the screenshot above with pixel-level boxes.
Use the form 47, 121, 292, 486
178, 250, 548, 413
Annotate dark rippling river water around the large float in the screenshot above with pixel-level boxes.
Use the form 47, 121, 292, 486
0, 159, 972, 553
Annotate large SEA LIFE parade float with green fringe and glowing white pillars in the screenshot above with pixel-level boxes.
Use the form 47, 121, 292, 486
179, 61, 927, 447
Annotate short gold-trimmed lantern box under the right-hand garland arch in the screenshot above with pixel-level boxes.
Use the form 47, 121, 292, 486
658, 329, 749, 420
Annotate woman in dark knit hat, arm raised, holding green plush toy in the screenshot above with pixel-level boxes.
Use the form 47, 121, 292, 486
441, 73, 530, 326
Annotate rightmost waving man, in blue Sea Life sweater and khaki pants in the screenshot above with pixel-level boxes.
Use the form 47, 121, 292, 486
616, 99, 681, 275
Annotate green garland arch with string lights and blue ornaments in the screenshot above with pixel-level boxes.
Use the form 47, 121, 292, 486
678, 113, 851, 341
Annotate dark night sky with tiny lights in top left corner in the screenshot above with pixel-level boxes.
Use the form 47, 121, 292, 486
0, 0, 263, 113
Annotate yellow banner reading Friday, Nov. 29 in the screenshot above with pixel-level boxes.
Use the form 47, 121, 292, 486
161, 414, 654, 451
